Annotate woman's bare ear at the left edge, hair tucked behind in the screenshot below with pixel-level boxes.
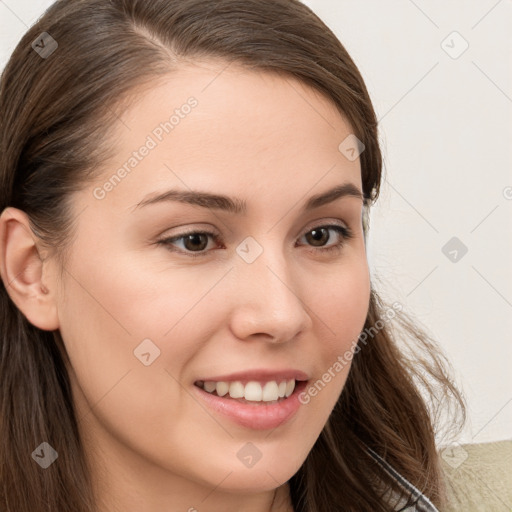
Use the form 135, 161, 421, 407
0, 207, 59, 331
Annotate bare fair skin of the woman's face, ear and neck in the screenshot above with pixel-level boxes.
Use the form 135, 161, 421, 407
0, 61, 370, 512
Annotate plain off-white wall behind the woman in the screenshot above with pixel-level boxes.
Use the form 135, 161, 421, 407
0, 0, 512, 443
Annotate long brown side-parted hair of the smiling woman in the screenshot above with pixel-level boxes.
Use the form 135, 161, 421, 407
0, 0, 464, 512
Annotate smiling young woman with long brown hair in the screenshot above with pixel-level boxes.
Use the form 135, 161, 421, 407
0, 0, 463, 512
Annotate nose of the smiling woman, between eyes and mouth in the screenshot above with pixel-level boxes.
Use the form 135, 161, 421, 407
231, 247, 312, 343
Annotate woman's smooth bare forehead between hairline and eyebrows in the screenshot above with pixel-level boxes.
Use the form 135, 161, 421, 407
84, 61, 361, 216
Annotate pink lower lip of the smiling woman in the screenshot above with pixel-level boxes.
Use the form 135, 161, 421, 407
193, 381, 307, 430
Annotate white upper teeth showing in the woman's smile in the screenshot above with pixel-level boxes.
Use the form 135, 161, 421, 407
203, 379, 295, 402
